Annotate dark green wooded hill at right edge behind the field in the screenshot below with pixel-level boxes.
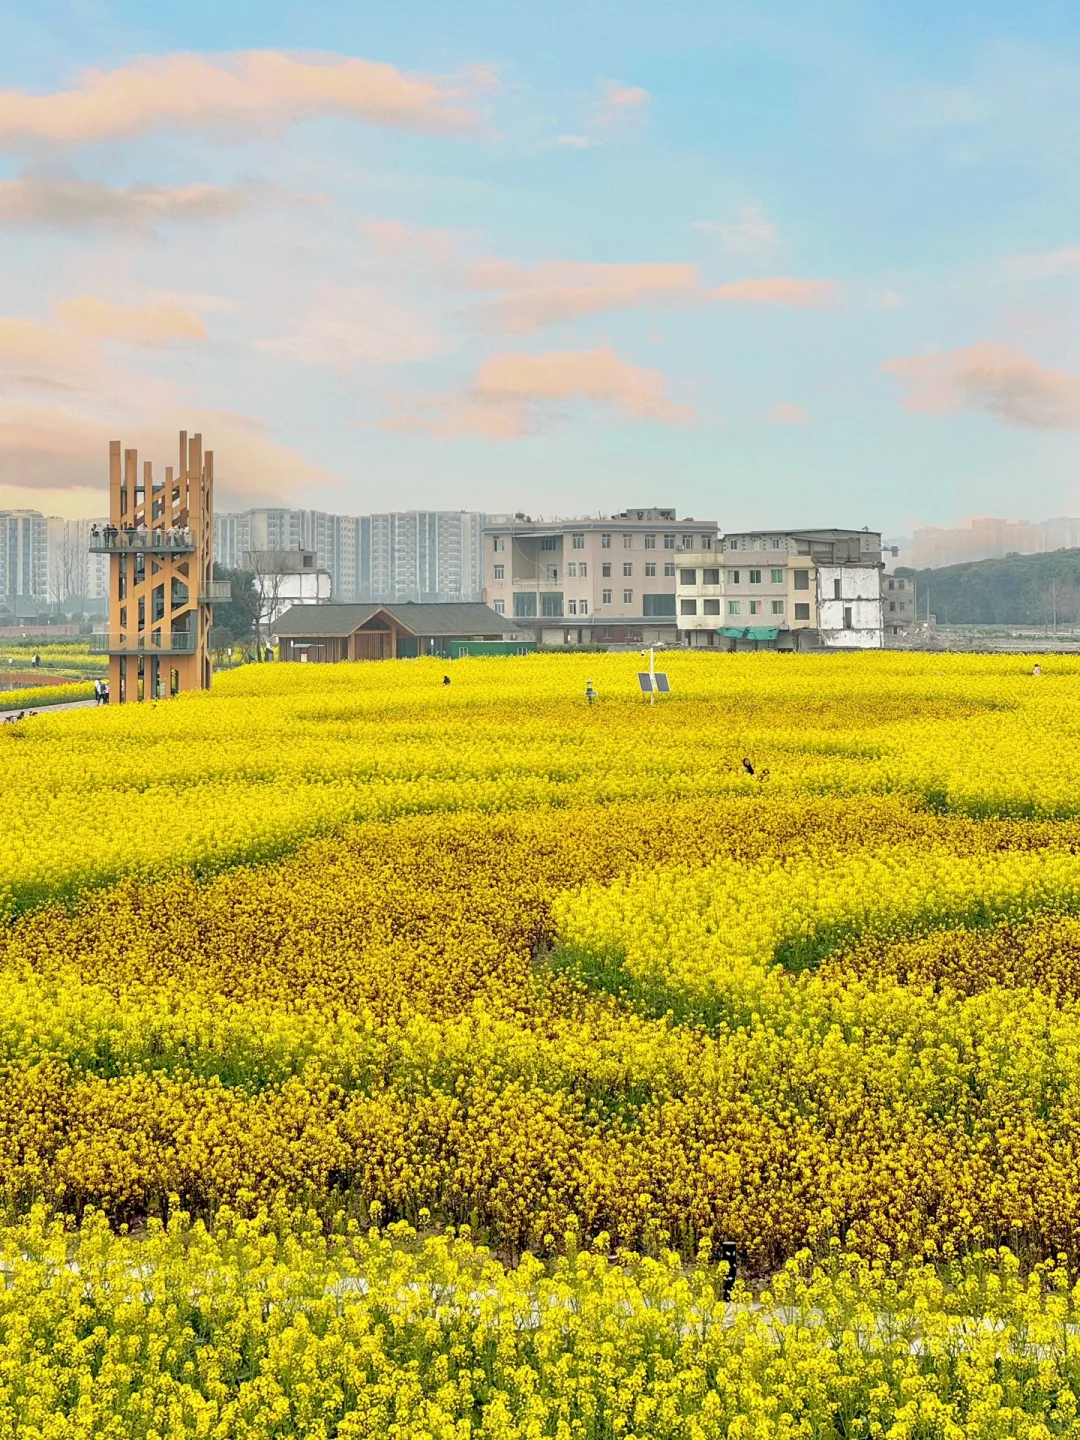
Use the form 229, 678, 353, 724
896, 550, 1080, 625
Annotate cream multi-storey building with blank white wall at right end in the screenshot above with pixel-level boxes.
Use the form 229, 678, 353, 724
677, 530, 883, 649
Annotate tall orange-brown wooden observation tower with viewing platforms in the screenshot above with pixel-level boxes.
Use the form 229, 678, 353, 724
91, 431, 229, 704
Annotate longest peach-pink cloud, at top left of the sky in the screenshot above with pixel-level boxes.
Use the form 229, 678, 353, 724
0, 50, 477, 150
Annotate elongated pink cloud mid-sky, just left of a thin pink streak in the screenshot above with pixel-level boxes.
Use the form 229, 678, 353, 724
468, 261, 700, 334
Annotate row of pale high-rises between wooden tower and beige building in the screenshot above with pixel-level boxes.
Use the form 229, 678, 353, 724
215, 508, 484, 605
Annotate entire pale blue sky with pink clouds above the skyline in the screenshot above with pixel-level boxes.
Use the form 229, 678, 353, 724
0, 0, 1080, 536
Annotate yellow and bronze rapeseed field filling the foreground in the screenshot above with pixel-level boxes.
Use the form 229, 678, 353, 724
0, 654, 1080, 1440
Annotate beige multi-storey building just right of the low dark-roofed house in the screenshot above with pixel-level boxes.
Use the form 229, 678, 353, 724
484, 508, 719, 645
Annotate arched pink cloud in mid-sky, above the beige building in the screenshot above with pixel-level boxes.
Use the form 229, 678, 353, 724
387, 348, 693, 439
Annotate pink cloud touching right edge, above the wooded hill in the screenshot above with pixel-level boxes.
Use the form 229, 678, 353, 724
881, 340, 1080, 431
